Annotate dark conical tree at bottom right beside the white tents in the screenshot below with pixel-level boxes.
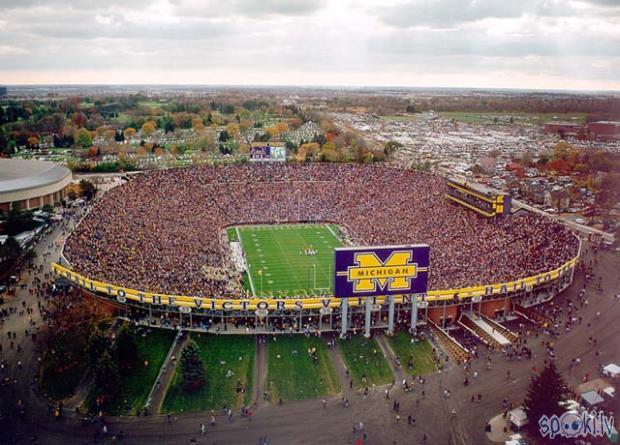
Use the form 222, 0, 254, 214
523, 362, 567, 442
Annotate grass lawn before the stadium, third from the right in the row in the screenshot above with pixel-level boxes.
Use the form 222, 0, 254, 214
267, 335, 340, 403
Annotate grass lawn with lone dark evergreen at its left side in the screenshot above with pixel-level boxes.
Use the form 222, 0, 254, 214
162, 334, 256, 413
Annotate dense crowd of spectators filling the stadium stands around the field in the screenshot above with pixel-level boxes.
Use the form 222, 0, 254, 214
65, 163, 578, 297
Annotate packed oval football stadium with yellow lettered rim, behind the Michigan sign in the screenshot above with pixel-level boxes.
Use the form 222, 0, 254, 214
53, 163, 580, 343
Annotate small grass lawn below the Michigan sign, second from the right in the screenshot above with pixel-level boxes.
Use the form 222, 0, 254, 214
338, 335, 394, 388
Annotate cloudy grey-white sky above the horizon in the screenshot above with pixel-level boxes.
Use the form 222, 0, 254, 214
0, 0, 620, 90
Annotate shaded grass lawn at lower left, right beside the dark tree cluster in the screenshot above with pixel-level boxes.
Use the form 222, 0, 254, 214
110, 329, 176, 414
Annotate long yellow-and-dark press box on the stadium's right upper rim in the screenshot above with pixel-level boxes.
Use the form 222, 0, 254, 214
446, 178, 512, 218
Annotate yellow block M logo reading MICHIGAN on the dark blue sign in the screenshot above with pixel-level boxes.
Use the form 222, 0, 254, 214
346, 250, 418, 292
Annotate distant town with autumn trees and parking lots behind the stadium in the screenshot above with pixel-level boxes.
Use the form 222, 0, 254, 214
0, 86, 620, 238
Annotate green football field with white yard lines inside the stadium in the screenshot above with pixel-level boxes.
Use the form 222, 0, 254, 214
228, 224, 342, 297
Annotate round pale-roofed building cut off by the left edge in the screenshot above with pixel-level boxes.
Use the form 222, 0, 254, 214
0, 158, 72, 213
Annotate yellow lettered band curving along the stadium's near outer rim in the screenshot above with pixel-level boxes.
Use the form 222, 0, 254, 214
52, 256, 579, 310
